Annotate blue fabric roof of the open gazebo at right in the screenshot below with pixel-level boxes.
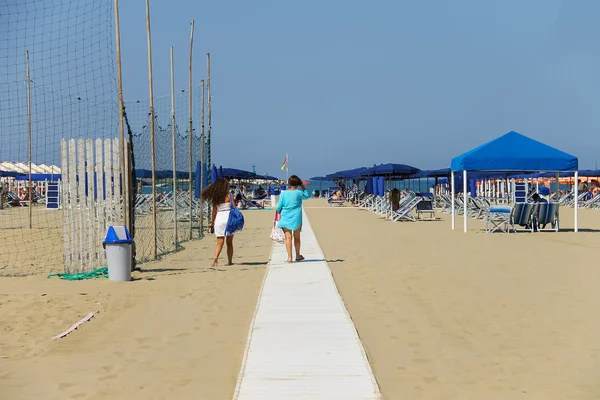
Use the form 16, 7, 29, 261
450, 132, 578, 172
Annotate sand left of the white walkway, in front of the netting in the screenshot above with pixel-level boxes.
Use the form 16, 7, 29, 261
0, 211, 273, 400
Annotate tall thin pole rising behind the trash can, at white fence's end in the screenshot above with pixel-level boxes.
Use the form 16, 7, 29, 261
114, 0, 131, 231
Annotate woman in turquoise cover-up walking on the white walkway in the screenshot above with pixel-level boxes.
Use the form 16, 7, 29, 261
277, 175, 310, 263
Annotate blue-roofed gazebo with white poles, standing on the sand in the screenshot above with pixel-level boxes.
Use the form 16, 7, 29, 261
450, 131, 578, 233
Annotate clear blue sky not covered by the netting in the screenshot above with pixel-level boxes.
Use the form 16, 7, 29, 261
120, 0, 600, 177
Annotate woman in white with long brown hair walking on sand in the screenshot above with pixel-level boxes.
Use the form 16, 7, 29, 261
202, 179, 233, 267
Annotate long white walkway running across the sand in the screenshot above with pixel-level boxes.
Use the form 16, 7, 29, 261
233, 209, 380, 400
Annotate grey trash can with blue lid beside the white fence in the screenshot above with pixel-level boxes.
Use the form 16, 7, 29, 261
102, 226, 133, 282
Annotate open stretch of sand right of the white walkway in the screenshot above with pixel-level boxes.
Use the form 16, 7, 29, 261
306, 200, 600, 400
